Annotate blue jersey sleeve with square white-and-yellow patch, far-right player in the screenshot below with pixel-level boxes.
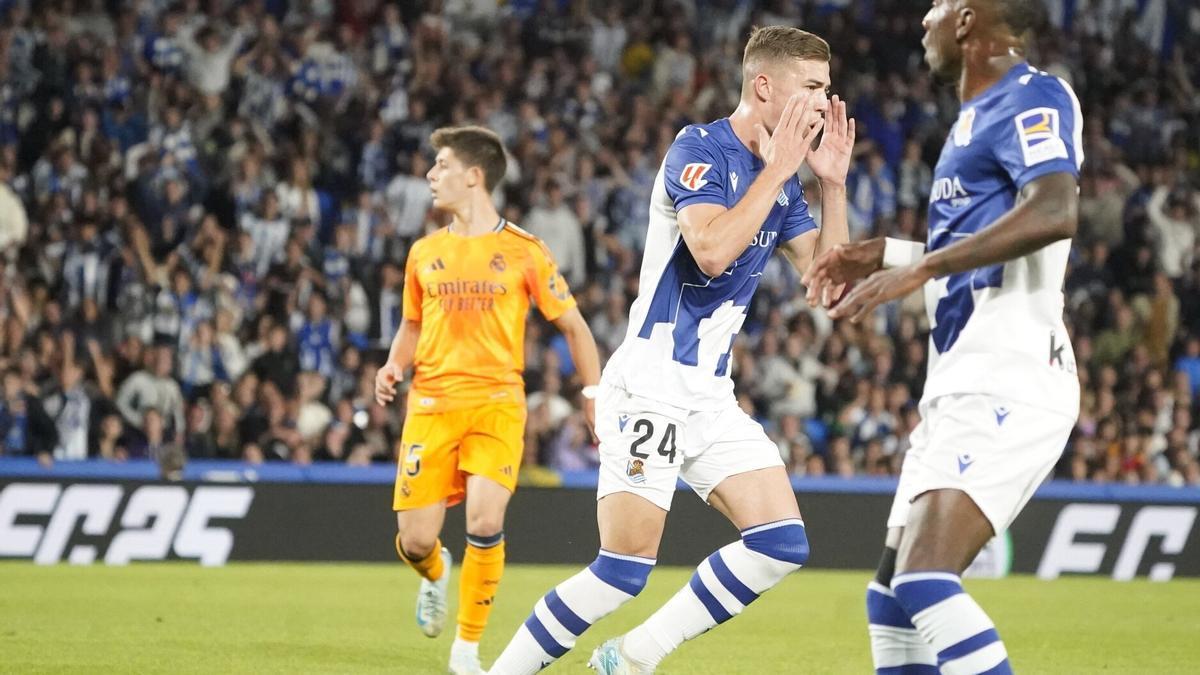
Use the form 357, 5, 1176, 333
995, 74, 1084, 190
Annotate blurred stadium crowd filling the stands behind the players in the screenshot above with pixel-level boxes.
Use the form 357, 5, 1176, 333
0, 0, 1200, 484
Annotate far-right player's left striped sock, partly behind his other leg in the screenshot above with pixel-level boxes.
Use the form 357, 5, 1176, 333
866, 578, 937, 675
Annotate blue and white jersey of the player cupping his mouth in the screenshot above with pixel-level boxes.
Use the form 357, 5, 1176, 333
604, 119, 817, 411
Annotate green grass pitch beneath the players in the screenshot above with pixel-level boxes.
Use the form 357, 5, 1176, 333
0, 562, 1200, 675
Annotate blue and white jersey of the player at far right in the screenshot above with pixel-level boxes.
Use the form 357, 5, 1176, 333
924, 62, 1084, 417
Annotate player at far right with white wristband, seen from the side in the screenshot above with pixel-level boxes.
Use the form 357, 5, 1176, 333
806, 0, 1084, 675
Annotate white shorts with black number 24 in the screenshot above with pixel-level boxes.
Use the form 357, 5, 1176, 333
596, 384, 784, 510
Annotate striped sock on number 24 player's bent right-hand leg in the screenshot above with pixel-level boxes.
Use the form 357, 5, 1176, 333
622, 519, 809, 670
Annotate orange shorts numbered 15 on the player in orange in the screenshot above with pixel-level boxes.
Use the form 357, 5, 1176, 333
392, 404, 526, 510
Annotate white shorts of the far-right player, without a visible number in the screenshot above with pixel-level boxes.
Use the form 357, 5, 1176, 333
888, 394, 1075, 533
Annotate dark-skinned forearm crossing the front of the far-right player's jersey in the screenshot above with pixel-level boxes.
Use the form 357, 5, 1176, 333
917, 174, 1079, 277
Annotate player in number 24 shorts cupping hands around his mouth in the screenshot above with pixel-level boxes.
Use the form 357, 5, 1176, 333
491, 26, 854, 675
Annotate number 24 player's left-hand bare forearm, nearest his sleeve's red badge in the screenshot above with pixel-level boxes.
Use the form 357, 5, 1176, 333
688, 169, 790, 276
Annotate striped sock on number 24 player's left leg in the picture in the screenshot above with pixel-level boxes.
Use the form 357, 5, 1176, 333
488, 550, 654, 675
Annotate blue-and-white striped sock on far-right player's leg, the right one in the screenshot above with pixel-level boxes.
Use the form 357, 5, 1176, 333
892, 572, 1013, 675
